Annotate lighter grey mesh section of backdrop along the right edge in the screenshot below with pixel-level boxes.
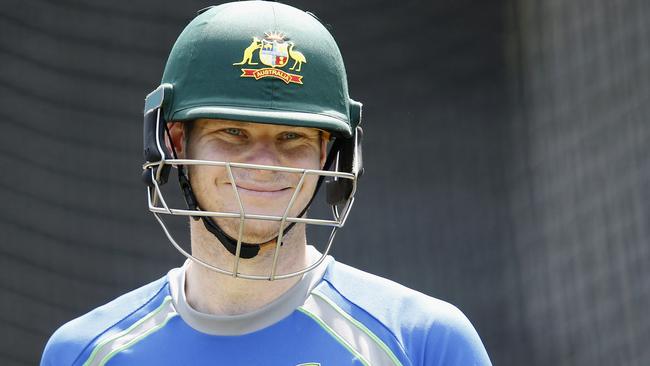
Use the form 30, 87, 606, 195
508, 1, 650, 365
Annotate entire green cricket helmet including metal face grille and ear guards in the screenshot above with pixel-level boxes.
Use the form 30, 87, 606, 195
143, 1, 362, 279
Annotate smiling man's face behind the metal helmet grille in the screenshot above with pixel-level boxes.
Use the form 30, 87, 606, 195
185, 119, 326, 243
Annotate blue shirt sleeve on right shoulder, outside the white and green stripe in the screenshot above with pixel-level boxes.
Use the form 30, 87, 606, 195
319, 262, 490, 365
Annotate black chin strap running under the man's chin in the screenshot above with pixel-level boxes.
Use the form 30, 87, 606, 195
165, 125, 340, 259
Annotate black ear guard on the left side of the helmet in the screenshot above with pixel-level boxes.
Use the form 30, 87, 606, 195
142, 84, 172, 186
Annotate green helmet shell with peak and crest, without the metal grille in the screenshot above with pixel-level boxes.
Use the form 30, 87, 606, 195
145, 1, 361, 137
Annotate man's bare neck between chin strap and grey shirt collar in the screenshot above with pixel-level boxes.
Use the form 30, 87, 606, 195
185, 220, 308, 315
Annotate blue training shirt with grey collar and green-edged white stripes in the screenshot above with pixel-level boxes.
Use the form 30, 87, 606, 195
41, 257, 491, 366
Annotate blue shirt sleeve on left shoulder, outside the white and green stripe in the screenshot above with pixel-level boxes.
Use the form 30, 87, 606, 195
41, 276, 168, 366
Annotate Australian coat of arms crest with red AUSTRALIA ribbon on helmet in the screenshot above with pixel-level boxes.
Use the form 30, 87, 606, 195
233, 32, 307, 84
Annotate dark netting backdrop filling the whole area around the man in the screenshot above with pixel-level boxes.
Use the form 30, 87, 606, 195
0, 0, 650, 365
